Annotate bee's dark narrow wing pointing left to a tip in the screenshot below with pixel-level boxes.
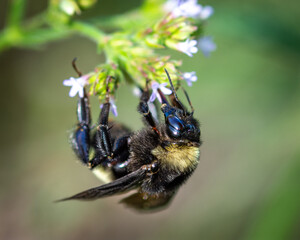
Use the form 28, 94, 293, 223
57, 168, 146, 202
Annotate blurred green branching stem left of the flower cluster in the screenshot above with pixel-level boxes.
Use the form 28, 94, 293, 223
0, 0, 146, 52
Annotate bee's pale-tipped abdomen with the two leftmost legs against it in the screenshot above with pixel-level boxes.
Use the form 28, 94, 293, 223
71, 79, 130, 182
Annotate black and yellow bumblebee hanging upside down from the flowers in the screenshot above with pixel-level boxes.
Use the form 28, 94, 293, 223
60, 71, 201, 210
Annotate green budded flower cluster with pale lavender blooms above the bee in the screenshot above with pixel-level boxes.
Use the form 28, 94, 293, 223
61, 0, 216, 116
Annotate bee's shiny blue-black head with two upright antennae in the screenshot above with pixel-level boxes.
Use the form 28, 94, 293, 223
158, 70, 200, 142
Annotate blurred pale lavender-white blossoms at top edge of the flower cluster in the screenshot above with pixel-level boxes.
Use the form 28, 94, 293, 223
164, 0, 213, 20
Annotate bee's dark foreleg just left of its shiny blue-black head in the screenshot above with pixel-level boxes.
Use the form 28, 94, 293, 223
138, 87, 159, 135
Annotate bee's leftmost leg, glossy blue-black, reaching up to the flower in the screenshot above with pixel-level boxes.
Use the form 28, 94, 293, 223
71, 90, 91, 164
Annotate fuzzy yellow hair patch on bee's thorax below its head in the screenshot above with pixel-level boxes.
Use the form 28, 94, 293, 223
151, 144, 200, 172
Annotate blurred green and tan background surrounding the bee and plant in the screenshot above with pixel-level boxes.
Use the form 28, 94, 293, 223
0, 0, 300, 240
